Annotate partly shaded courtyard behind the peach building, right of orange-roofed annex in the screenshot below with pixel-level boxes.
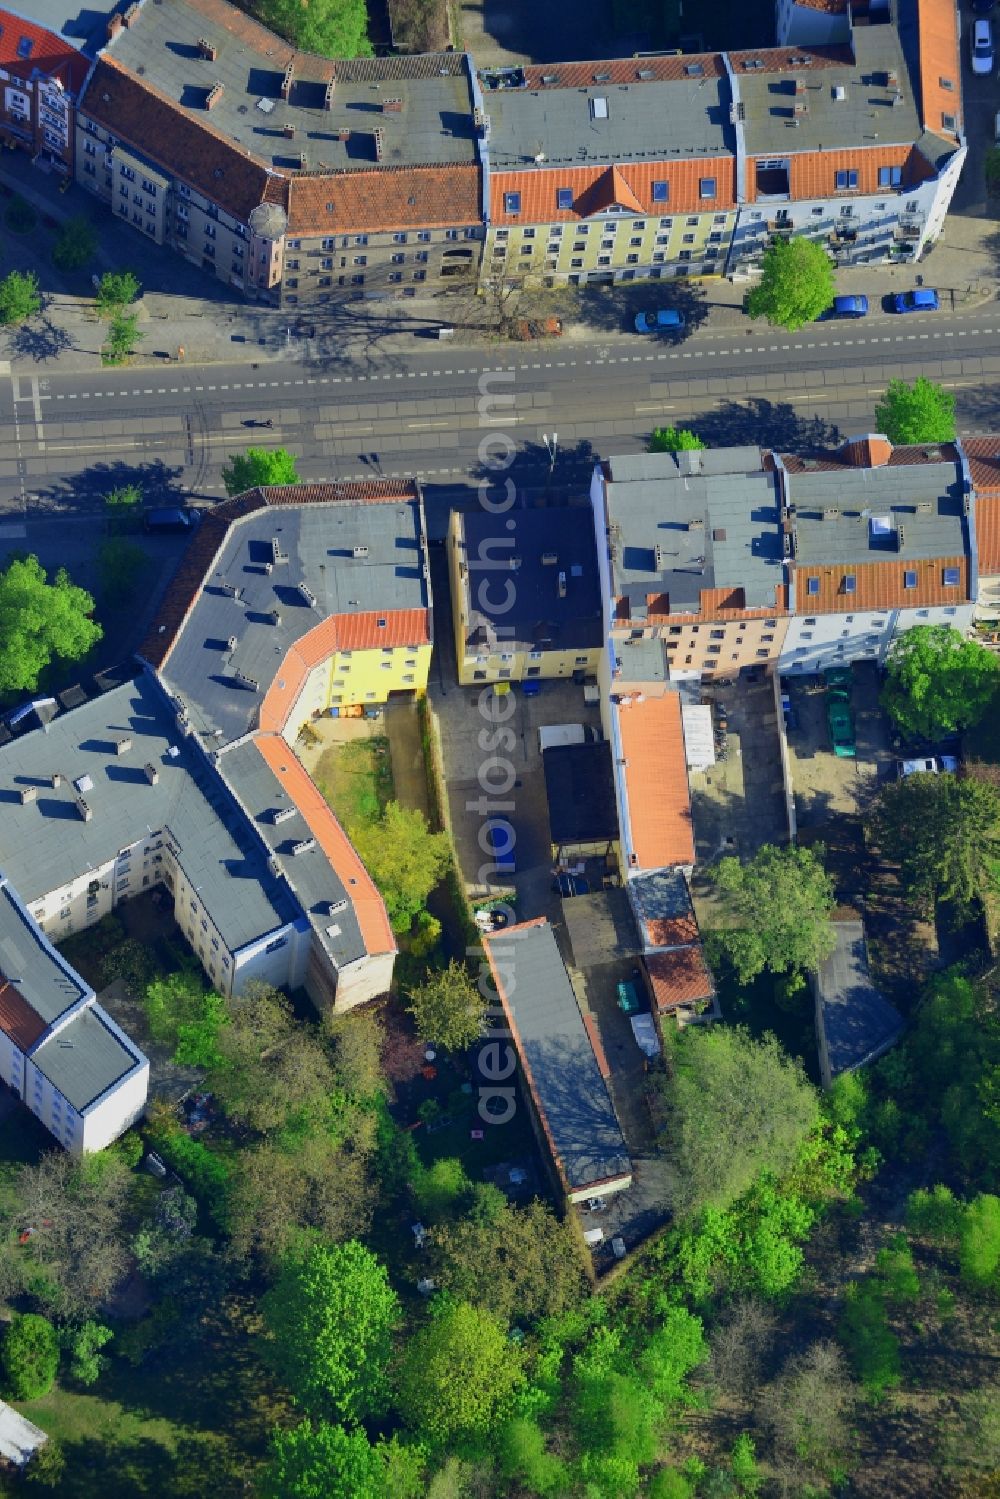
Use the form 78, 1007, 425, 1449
690, 678, 789, 865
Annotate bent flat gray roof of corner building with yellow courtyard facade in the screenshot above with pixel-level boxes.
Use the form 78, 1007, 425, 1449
159, 498, 429, 744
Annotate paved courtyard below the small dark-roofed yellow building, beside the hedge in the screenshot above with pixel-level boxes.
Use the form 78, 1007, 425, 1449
430, 681, 601, 920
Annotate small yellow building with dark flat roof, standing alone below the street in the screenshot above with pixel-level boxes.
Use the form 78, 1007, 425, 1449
447, 508, 604, 687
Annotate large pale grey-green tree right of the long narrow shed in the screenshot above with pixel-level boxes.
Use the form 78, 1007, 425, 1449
663, 1025, 819, 1213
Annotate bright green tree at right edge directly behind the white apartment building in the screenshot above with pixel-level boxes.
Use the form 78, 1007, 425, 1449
882, 625, 1000, 739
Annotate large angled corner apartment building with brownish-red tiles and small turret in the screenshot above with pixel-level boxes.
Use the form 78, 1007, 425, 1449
76, 0, 483, 307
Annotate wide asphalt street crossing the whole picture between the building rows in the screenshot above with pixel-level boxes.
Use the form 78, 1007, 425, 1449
0, 303, 1000, 535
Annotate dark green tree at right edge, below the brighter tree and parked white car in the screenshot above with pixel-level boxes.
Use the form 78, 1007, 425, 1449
868, 775, 1000, 908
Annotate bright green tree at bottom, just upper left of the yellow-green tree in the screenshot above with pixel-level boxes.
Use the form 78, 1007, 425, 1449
262, 1240, 399, 1423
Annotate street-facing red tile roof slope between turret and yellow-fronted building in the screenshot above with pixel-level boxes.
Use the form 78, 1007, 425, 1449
288, 162, 483, 234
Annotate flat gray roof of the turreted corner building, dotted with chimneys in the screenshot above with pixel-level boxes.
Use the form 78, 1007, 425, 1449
109, 0, 477, 171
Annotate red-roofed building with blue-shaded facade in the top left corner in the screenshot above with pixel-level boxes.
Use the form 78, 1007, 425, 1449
0, 10, 90, 175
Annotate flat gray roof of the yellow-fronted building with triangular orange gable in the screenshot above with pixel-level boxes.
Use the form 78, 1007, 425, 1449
483, 64, 736, 171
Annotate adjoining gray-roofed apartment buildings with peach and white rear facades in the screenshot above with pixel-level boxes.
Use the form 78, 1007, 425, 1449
592, 436, 979, 696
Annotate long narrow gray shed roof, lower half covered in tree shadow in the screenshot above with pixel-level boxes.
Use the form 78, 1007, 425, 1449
487, 922, 631, 1192
